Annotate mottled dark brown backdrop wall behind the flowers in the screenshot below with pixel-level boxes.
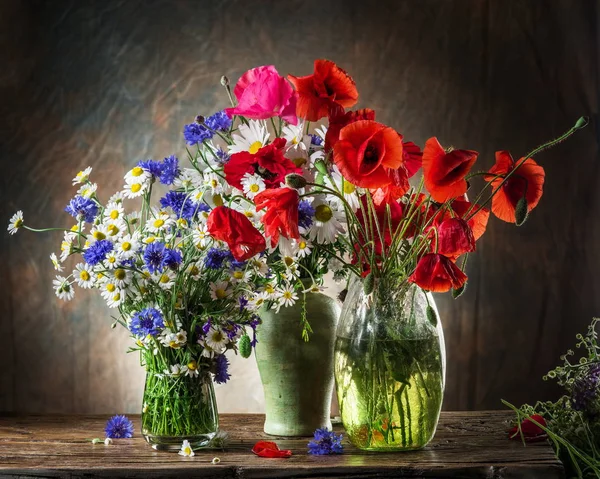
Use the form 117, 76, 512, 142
0, 0, 600, 412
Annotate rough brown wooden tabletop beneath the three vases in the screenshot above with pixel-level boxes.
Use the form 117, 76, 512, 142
0, 411, 564, 479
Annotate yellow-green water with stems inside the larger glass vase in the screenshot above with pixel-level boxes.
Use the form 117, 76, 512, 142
335, 335, 444, 451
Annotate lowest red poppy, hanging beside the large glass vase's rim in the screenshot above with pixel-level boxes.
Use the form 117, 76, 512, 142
408, 253, 467, 293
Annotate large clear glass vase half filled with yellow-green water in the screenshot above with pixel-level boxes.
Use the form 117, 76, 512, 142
335, 278, 446, 451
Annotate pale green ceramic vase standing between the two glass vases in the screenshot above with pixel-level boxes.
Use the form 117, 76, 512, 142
255, 293, 340, 436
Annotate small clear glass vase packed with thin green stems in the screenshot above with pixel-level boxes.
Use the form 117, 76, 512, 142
142, 371, 219, 451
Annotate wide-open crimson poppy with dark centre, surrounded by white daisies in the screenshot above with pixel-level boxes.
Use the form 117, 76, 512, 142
223, 138, 302, 190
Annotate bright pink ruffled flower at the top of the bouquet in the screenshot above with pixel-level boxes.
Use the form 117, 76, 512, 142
225, 65, 298, 125
